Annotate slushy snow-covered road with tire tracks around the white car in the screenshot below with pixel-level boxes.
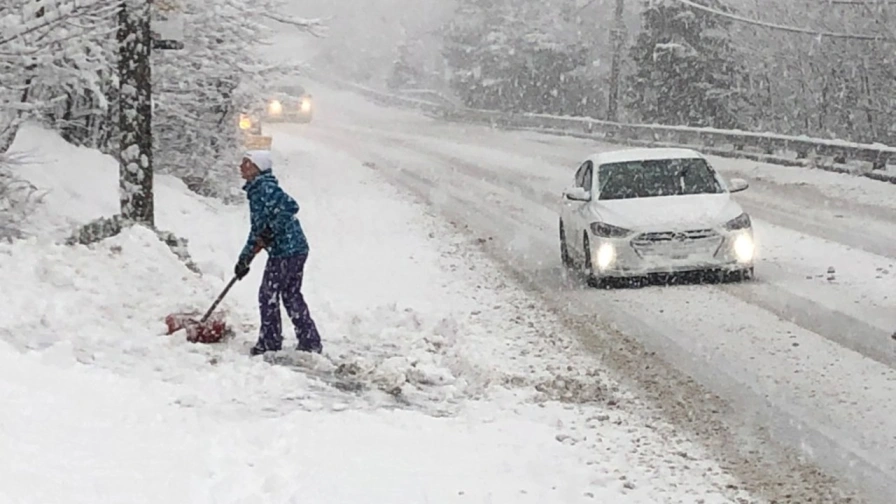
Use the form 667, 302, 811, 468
288, 80, 896, 502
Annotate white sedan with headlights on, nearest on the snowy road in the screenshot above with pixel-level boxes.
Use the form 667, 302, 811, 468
560, 148, 755, 286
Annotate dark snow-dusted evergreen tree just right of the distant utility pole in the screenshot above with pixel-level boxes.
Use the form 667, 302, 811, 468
629, 0, 748, 128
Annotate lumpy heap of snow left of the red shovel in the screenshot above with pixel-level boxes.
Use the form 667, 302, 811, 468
0, 226, 206, 349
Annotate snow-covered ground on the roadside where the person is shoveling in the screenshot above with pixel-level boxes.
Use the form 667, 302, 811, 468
0, 127, 776, 503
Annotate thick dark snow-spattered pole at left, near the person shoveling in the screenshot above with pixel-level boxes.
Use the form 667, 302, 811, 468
117, 0, 155, 228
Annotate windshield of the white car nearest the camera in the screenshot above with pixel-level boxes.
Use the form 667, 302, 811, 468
598, 158, 724, 200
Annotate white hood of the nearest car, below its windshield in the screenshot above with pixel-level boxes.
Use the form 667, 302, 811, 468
591, 193, 743, 231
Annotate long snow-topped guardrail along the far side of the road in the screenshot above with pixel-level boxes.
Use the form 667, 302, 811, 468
315, 75, 896, 184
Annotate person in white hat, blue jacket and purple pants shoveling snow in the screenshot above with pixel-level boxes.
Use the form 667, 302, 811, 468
234, 150, 322, 355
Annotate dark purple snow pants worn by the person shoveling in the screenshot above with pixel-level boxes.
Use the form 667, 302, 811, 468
258, 255, 321, 351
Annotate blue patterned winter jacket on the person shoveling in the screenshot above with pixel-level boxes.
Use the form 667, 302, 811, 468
240, 171, 308, 259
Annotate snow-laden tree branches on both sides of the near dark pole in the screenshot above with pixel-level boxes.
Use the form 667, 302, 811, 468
0, 0, 326, 198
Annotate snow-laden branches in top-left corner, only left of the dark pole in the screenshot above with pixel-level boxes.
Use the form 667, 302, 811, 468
0, 0, 117, 151
